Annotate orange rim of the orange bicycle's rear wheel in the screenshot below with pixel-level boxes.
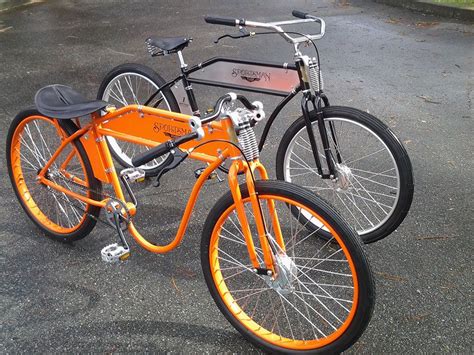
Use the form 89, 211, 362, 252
10, 116, 89, 234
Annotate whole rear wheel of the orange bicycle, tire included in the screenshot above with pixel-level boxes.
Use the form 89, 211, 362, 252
6, 109, 101, 242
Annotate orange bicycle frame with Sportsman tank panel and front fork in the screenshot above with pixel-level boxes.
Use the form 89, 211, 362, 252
38, 105, 284, 270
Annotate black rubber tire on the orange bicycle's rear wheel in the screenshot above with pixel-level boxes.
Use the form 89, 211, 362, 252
6, 108, 102, 243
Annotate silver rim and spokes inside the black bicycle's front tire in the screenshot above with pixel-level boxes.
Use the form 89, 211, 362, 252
283, 117, 400, 235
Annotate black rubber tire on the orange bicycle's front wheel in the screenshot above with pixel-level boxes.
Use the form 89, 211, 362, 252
201, 181, 375, 354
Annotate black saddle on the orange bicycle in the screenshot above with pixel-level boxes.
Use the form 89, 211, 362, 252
35, 84, 108, 119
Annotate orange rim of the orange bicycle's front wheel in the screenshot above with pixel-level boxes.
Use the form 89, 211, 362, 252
209, 194, 359, 350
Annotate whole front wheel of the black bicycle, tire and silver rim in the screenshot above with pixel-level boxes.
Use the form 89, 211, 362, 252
276, 106, 413, 243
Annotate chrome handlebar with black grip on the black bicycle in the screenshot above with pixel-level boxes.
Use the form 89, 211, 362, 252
204, 10, 326, 45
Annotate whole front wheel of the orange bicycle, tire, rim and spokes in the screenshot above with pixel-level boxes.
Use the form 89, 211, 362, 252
201, 181, 375, 354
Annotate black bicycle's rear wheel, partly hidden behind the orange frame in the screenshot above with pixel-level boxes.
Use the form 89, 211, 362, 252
97, 63, 179, 176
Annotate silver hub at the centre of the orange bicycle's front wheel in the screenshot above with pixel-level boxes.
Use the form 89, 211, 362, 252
264, 253, 298, 295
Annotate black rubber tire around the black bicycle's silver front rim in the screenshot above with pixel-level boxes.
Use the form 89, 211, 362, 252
276, 106, 414, 243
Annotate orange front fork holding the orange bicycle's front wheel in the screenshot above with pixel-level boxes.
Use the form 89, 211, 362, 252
228, 161, 285, 275
